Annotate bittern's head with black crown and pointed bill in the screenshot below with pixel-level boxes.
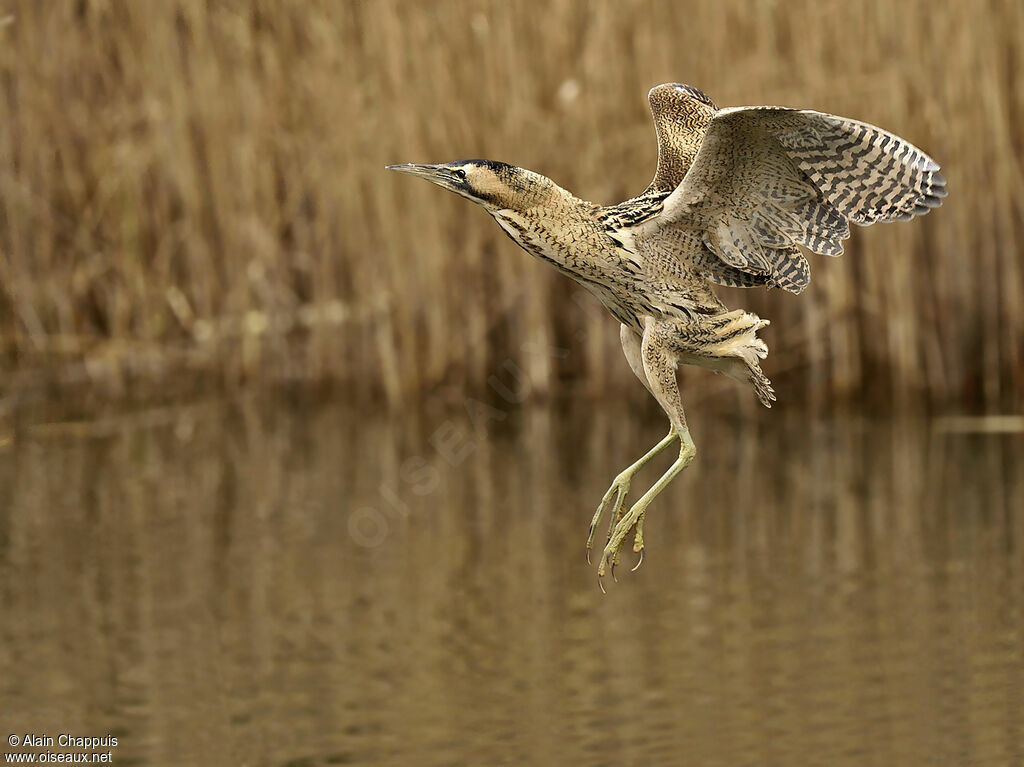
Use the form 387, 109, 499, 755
387, 160, 551, 211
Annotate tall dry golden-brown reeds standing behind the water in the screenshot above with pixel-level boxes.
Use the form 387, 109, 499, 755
0, 0, 1024, 410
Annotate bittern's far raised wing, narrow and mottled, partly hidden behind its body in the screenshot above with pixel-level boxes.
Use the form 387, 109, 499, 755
645, 83, 718, 194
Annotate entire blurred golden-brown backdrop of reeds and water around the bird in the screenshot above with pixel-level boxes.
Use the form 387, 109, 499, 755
0, 0, 1024, 767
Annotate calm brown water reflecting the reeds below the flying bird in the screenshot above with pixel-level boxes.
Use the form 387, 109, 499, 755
0, 403, 1024, 767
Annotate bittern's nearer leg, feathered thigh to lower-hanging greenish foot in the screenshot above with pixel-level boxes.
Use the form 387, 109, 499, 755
597, 317, 696, 589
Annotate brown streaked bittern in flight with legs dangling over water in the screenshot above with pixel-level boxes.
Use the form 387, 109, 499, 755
388, 84, 946, 590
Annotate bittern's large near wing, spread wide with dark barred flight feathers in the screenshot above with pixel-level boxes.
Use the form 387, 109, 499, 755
650, 106, 946, 293
